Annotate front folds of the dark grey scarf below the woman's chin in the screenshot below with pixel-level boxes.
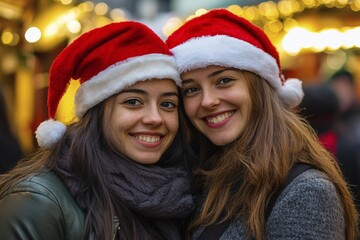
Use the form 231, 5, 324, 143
106, 158, 194, 218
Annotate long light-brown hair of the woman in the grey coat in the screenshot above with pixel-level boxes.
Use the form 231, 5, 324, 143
189, 71, 357, 239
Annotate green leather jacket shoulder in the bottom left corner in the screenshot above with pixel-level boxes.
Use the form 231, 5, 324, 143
0, 171, 85, 240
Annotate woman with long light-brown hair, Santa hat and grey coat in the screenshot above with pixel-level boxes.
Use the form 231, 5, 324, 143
166, 9, 357, 240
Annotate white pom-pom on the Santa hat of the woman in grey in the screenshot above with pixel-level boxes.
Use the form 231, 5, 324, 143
278, 78, 304, 108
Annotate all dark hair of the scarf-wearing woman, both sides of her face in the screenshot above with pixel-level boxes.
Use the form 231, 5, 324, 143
0, 94, 188, 240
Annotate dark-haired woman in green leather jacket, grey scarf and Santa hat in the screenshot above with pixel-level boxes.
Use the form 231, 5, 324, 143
0, 22, 194, 240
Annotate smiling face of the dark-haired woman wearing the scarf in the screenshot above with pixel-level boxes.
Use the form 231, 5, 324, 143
104, 79, 179, 164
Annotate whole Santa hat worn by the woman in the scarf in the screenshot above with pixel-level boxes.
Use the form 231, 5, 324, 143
36, 21, 180, 148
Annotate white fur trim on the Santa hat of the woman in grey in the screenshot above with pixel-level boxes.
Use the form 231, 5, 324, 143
171, 35, 281, 89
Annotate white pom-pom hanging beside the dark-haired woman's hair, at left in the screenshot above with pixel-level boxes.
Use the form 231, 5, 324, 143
35, 119, 66, 148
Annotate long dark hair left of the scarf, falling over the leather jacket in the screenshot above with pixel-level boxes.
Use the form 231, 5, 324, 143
0, 103, 119, 239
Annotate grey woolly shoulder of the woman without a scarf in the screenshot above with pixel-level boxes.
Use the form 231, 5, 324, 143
267, 169, 345, 239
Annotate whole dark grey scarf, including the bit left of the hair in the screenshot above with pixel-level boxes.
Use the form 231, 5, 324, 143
55, 151, 194, 219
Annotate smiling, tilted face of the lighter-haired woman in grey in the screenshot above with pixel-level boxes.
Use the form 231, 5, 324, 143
181, 66, 251, 146
